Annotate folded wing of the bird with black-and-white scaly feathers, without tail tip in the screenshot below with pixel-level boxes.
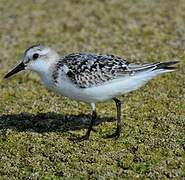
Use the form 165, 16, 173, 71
59, 53, 158, 88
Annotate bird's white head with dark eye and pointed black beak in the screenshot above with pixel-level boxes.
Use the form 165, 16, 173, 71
5, 45, 60, 78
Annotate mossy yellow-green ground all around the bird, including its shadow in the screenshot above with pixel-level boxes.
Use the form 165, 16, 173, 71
0, 0, 185, 179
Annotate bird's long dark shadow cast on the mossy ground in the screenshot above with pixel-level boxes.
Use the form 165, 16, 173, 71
0, 113, 115, 133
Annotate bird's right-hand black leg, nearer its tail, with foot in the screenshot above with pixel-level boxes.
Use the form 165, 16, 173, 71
107, 98, 121, 139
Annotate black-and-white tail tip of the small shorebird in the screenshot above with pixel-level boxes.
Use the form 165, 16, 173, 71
152, 61, 179, 72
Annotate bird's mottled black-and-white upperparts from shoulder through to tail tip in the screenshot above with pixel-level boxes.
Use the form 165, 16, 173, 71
50, 53, 177, 92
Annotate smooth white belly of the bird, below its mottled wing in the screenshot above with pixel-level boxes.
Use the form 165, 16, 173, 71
41, 70, 163, 103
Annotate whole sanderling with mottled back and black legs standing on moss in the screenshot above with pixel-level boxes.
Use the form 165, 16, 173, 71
5, 45, 178, 140
